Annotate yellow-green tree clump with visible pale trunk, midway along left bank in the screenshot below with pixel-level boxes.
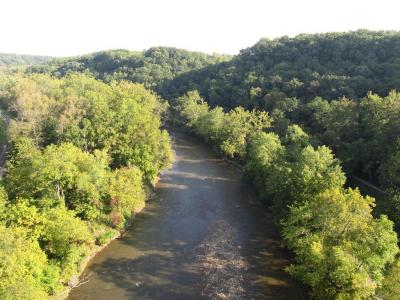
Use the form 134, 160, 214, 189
6, 139, 108, 219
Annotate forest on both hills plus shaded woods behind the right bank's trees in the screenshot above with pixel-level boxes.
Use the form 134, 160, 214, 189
31, 30, 400, 230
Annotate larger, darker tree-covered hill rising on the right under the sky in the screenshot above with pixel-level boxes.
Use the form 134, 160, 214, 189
159, 30, 400, 109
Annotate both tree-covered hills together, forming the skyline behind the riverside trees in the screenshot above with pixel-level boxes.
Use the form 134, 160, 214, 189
31, 30, 400, 109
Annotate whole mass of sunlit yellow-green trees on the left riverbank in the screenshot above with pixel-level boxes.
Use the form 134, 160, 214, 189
0, 74, 172, 299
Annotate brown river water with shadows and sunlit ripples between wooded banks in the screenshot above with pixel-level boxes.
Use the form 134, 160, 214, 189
68, 133, 306, 300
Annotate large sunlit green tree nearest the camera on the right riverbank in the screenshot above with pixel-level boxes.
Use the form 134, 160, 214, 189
283, 189, 398, 299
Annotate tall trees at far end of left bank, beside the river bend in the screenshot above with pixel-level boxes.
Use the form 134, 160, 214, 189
2, 74, 172, 182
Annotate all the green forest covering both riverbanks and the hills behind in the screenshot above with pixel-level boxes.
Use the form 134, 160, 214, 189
0, 30, 400, 299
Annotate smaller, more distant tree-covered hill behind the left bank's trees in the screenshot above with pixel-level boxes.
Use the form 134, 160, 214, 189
31, 47, 231, 90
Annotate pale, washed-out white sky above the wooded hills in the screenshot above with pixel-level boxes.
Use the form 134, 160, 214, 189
0, 0, 400, 56
